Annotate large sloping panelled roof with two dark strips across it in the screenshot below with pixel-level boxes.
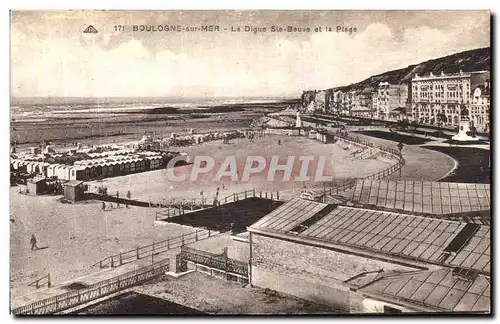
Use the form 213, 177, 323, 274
248, 199, 490, 274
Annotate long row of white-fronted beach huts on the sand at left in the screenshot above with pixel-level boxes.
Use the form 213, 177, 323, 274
10, 152, 174, 181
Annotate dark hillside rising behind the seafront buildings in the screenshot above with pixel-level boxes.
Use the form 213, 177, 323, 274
302, 47, 491, 101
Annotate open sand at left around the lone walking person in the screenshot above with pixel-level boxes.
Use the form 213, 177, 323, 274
10, 187, 197, 297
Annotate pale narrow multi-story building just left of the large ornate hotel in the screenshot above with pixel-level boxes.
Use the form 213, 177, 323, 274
377, 82, 408, 119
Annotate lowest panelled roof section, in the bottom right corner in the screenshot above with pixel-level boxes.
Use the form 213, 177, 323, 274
346, 269, 491, 312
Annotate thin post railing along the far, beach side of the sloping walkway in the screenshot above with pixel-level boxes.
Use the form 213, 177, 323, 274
90, 229, 219, 269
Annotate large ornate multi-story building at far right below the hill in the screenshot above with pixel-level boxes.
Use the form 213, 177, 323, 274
411, 71, 490, 129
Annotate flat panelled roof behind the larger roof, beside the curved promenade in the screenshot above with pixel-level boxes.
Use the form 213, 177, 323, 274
350, 180, 490, 215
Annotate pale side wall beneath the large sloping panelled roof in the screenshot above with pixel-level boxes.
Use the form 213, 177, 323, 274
250, 233, 417, 310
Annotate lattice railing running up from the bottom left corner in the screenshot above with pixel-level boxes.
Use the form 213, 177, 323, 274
11, 259, 170, 315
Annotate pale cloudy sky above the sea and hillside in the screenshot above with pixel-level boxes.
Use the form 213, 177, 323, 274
10, 10, 490, 98
